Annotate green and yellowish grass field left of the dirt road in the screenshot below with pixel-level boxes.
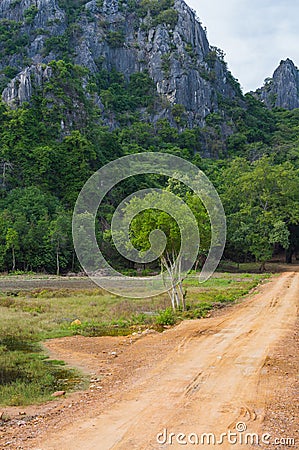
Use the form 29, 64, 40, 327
0, 273, 267, 405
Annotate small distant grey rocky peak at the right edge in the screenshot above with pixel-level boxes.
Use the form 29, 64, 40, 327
255, 59, 299, 110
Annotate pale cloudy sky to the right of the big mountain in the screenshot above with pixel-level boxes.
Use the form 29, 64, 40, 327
186, 0, 299, 92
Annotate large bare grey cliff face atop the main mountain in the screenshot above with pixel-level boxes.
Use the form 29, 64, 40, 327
0, 0, 240, 127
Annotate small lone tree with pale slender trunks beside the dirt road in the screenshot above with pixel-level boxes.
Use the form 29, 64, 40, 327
114, 186, 209, 309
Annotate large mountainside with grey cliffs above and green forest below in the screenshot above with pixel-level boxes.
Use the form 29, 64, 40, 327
0, 0, 299, 273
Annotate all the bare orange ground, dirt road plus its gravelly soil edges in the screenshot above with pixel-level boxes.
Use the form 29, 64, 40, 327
0, 271, 299, 450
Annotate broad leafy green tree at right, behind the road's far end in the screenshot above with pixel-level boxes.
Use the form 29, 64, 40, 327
222, 156, 299, 270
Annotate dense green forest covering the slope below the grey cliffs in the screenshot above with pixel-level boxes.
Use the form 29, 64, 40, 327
0, 60, 299, 274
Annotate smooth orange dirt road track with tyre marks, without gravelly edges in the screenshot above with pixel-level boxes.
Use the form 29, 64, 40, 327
31, 272, 299, 450
